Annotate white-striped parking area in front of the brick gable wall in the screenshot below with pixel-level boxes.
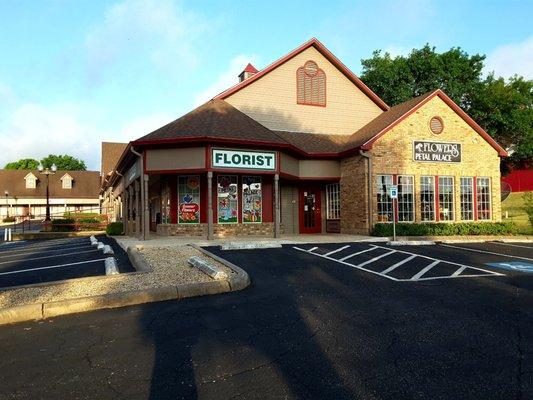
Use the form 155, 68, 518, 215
293, 242, 533, 282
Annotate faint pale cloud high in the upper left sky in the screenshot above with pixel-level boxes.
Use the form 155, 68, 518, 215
86, 0, 209, 83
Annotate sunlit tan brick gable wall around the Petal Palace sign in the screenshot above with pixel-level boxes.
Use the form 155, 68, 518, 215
368, 97, 501, 222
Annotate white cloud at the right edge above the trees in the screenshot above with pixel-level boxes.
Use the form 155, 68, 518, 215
485, 36, 533, 79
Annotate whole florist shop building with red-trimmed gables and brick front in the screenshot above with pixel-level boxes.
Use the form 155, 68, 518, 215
102, 39, 506, 237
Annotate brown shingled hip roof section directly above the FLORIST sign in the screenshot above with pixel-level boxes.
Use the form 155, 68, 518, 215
133, 99, 286, 144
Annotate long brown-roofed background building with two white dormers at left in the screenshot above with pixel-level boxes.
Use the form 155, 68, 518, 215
0, 169, 100, 219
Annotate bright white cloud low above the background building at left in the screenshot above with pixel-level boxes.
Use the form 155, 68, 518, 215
0, 103, 171, 170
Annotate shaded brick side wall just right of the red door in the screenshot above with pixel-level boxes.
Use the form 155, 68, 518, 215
340, 155, 369, 234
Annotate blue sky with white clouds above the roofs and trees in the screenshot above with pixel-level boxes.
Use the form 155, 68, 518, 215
0, 0, 533, 170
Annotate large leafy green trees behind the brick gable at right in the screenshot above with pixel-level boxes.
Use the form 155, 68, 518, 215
361, 45, 533, 165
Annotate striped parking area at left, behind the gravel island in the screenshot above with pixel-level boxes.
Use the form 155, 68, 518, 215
0, 237, 133, 288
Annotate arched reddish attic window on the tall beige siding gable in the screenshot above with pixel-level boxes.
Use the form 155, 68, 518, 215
296, 61, 326, 107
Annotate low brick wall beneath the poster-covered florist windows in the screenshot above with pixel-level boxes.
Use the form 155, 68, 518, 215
157, 222, 274, 237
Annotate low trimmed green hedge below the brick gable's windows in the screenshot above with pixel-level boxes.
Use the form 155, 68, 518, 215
372, 222, 518, 237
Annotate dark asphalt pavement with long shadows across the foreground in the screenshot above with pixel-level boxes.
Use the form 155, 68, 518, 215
0, 239, 533, 400
